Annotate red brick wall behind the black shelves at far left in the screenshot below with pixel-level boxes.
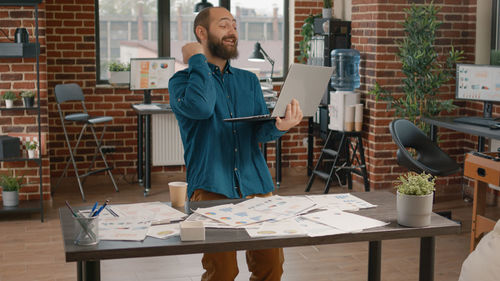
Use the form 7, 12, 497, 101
0, 4, 50, 200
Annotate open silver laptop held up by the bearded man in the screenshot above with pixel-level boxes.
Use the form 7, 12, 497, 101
224, 64, 333, 122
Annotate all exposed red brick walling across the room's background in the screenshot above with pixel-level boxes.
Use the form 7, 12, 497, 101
0, 0, 484, 200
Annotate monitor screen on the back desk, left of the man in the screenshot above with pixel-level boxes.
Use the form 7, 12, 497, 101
130, 58, 175, 90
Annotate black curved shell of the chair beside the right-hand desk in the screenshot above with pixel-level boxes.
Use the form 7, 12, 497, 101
389, 119, 460, 176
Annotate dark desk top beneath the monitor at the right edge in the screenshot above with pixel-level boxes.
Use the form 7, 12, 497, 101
422, 117, 500, 140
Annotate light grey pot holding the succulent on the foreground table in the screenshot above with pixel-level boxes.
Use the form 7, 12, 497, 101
396, 191, 433, 227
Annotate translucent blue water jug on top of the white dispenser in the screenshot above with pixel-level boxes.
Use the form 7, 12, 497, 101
330, 49, 360, 91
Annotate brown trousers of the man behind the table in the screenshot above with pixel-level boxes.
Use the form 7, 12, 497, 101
191, 189, 285, 281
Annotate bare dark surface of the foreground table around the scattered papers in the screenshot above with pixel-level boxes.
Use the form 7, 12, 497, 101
59, 191, 460, 262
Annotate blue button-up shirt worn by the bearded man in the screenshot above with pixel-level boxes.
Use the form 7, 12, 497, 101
169, 54, 284, 198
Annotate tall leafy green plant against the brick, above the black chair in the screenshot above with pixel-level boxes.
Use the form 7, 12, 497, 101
370, 2, 463, 132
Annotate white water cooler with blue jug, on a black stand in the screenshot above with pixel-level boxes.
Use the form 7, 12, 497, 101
328, 49, 360, 131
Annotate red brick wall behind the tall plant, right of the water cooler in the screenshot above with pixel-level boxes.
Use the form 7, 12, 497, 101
352, 0, 476, 192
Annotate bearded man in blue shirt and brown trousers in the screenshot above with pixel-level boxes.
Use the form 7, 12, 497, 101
169, 7, 302, 281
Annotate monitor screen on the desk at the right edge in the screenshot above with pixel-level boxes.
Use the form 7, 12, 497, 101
456, 64, 500, 102
